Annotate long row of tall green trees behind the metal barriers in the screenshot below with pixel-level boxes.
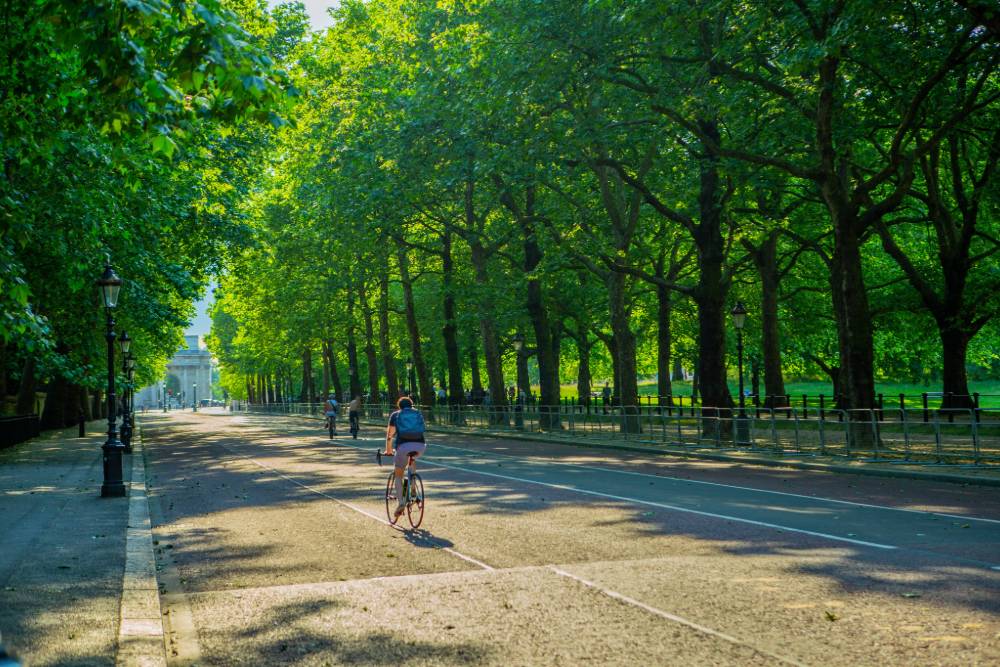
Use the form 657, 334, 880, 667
212, 0, 1000, 436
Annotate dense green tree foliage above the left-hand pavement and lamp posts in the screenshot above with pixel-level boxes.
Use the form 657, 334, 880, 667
0, 0, 296, 426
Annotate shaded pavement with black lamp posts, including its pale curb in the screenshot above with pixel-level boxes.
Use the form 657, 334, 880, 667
0, 421, 165, 667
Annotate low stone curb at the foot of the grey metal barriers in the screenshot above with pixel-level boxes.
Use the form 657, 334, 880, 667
256, 413, 1000, 486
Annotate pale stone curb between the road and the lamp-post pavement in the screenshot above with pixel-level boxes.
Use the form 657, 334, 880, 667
115, 429, 167, 667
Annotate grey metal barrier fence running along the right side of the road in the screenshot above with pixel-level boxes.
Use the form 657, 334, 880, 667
232, 403, 1000, 466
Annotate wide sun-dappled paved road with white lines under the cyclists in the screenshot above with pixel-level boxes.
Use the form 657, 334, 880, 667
144, 413, 1000, 665
